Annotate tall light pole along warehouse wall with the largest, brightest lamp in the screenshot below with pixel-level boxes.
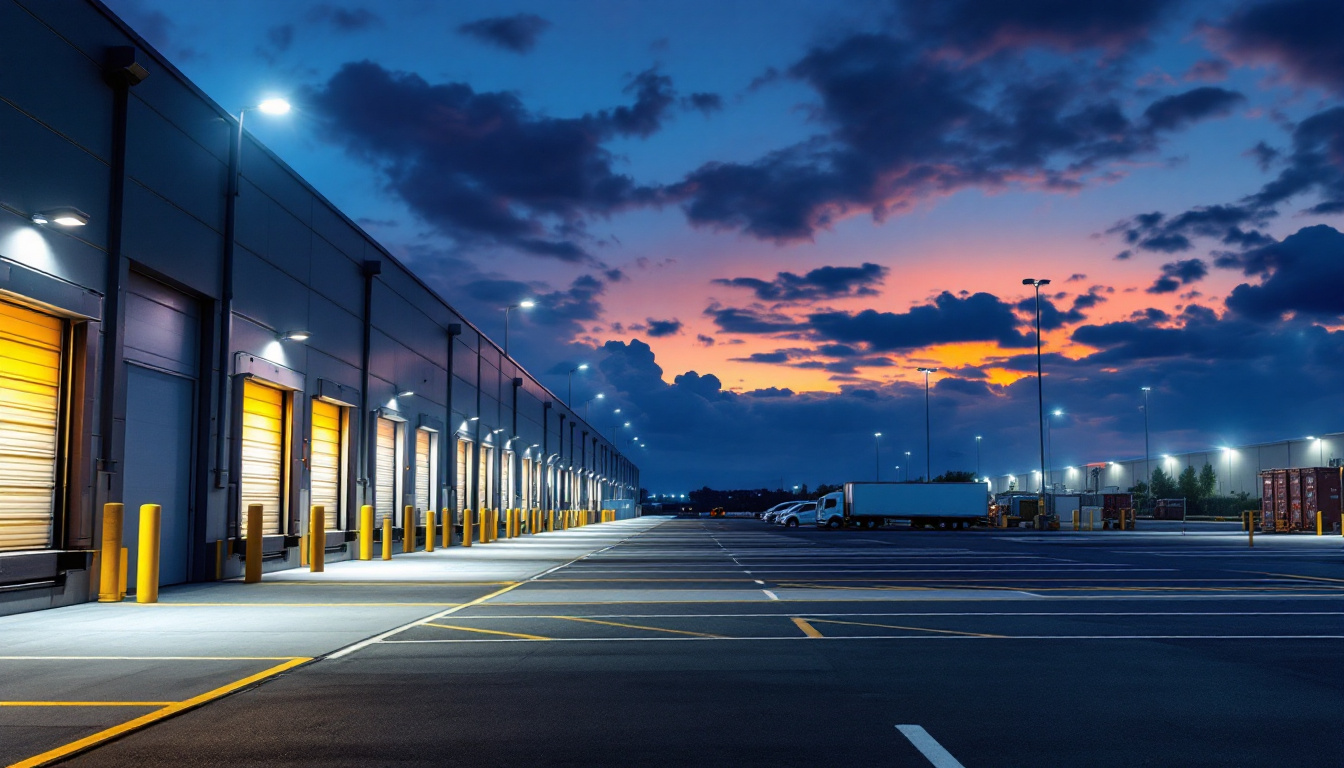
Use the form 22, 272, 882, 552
215, 98, 289, 488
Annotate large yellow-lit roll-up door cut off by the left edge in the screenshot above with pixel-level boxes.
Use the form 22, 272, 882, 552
0, 301, 65, 551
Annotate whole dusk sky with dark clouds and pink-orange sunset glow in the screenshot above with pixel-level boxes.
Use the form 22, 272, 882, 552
105, 0, 1344, 492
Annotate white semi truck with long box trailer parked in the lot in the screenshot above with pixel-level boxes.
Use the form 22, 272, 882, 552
817, 483, 989, 530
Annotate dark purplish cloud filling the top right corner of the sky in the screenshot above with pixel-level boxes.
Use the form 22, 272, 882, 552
1208, 0, 1344, 91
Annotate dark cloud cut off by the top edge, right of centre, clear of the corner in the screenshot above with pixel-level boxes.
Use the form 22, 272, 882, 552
903, 0, 1173, 56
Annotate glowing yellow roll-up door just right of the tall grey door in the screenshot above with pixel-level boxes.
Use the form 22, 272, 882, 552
238, 379, 285, 535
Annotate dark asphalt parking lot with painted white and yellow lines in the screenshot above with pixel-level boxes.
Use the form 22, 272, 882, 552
0, 519, 1344, 768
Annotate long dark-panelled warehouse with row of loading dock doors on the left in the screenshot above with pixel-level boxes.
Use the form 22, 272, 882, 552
0, 0, 638, 613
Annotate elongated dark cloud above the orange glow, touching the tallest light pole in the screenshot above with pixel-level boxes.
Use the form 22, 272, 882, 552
808, 292, 1028, 351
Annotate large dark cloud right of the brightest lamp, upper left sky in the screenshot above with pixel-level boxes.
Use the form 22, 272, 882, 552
308, 61, 673, 262
